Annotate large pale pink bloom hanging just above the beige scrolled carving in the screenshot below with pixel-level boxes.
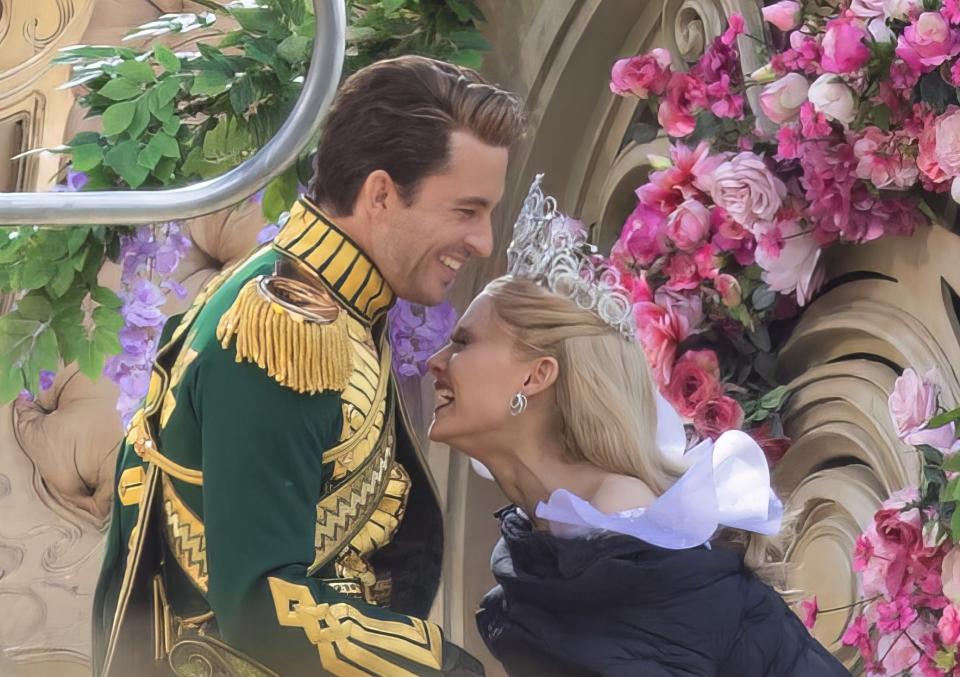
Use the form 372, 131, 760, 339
754, 221, 824, 306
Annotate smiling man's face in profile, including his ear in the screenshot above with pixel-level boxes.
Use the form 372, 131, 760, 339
370, 131, 507, 305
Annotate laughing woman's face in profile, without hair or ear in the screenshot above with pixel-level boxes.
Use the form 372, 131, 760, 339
428, 294, 530, 455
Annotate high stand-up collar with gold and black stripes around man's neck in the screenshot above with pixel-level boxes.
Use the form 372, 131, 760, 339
273, 198, 394, 324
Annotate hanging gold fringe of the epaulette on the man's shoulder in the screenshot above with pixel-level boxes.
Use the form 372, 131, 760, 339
217, 280, 353, 394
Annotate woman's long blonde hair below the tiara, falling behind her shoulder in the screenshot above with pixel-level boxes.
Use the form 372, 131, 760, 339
484, 275, 788, 587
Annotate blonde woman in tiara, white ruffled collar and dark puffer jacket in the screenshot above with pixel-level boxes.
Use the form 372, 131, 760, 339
430, 178, 847, 677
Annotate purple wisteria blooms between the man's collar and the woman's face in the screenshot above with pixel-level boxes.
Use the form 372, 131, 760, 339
389, 299, 458, 376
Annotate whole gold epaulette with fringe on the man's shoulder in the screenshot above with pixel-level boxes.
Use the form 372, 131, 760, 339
217, 276, 353, 394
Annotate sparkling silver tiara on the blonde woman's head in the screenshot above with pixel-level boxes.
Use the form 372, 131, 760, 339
507, 174, 636, 340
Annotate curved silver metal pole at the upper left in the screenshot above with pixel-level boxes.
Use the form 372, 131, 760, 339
0, 0, 347, 226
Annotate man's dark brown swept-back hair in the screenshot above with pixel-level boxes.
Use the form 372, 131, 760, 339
308, 56, 525, 216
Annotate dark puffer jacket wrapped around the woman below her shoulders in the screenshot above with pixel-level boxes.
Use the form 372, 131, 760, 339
477, 508, 849, 677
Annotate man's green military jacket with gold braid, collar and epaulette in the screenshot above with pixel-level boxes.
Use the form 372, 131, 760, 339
94, 201, 455, 677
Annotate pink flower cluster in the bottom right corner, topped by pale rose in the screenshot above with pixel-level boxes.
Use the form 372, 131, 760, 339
842, 369, 960, 677
